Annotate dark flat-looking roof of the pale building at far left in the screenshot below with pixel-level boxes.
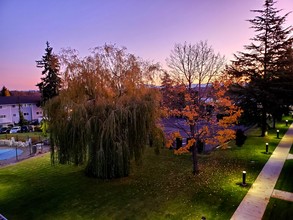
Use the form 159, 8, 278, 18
0, 95, 41, 105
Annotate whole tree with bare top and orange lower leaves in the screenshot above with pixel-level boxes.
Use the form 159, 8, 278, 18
165, 42, 241, 174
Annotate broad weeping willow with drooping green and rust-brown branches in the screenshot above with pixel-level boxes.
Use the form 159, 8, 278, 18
45, 45, 161, 179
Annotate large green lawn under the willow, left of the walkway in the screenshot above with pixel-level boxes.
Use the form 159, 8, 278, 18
0, 119, 286, 220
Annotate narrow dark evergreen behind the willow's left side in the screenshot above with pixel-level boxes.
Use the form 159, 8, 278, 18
36, 42, 61, 105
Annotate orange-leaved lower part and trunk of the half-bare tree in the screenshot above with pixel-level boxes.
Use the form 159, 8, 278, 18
164, 76, 242, 172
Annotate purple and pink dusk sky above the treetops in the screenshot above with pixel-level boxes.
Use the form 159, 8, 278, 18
0, 0, 293, 90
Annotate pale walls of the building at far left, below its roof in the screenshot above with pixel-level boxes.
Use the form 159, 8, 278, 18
0, 103, 43, 124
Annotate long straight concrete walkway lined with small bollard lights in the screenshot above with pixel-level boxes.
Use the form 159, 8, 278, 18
231, 124, 293, 220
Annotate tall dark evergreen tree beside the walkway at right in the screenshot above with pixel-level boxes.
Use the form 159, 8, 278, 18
228, 0, 293, 136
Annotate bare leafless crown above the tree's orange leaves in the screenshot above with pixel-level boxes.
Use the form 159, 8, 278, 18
166, 41, 225, 98
